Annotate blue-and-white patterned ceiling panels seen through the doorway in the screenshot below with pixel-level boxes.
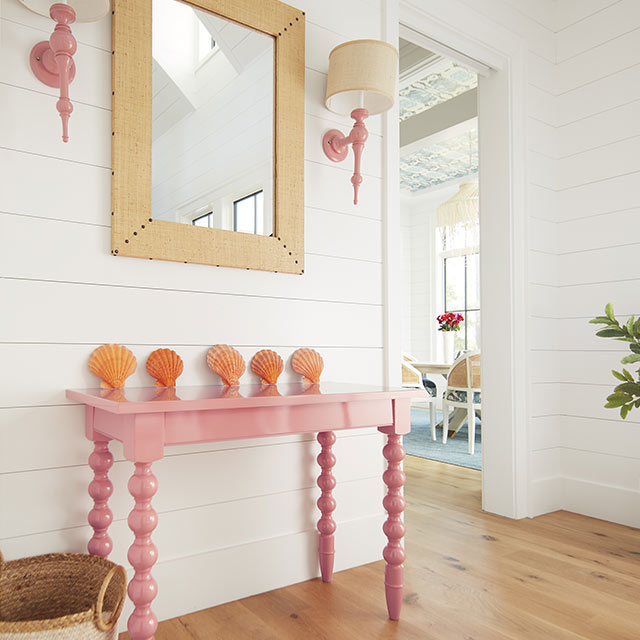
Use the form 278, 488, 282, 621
399, 38, 478, 194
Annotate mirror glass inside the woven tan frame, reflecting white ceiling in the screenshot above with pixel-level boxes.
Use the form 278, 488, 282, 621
151, 0, 275, 236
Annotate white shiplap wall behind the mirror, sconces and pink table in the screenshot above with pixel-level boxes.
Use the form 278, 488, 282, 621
0, 0, 384, 632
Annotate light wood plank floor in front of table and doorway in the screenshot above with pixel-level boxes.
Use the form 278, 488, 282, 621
120, 456, 640, 640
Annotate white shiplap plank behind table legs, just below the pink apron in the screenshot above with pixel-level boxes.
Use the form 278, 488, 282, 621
0, 433, 383, 538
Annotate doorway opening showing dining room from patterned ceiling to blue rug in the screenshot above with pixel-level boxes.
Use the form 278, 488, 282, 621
398, 35, 482, 469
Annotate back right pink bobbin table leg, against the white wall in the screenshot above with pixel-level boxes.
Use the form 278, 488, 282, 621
318, 431, 336, 582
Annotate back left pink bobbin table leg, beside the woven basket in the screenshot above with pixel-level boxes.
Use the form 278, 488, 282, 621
87, 440, 113, 558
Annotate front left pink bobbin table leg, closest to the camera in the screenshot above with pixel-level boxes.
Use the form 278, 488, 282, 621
127, 462, 158, 640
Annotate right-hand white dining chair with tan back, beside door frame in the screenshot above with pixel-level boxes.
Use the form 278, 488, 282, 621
442, 351, 482, 455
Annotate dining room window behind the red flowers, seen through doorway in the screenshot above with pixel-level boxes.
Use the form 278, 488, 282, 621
442, 252, 480, 351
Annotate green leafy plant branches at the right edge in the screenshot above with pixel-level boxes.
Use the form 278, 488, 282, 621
589, 302, 640, 419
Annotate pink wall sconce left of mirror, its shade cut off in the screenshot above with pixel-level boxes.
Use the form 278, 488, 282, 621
18, 0, 109, 142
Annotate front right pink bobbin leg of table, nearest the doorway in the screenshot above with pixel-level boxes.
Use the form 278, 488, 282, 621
382, 434, 405, 620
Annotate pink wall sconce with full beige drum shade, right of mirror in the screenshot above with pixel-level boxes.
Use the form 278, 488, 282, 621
322, 40, 398, 204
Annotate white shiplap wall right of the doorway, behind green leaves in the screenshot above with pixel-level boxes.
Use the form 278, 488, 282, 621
533, 0, 640, 526
